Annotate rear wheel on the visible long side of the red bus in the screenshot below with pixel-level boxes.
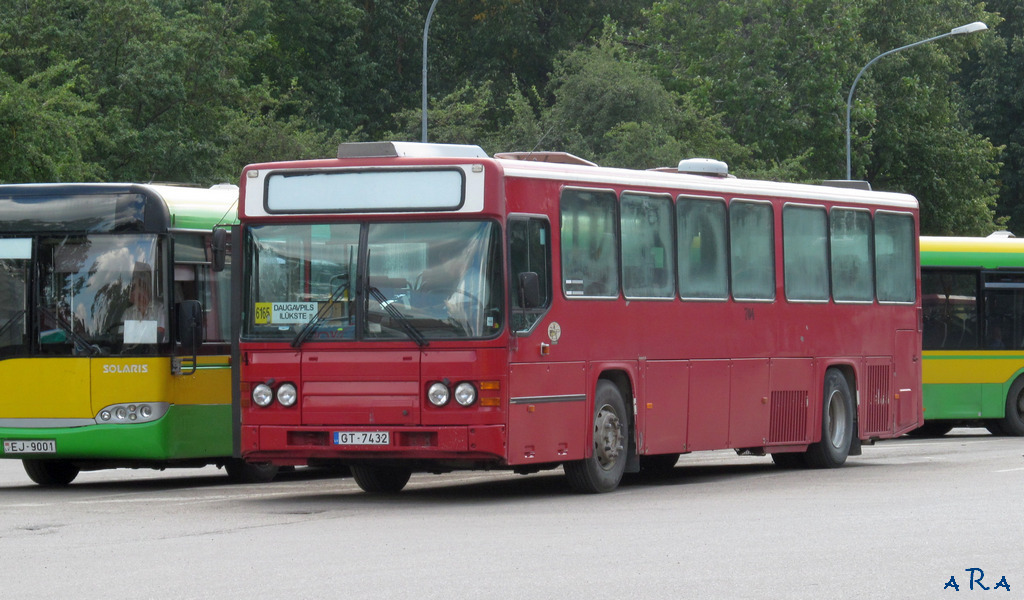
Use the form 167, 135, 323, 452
804, 369, 856, 469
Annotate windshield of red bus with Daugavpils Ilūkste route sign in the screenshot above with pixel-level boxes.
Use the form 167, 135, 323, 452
244, 221, 504, 347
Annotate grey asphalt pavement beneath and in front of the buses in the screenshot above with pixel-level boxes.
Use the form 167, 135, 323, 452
0, 429, 1024, 600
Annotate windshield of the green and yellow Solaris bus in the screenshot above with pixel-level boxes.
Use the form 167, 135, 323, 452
0, 234, 168, 355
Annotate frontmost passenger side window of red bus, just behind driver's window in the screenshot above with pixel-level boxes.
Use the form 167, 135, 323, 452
561, 189, 618, 298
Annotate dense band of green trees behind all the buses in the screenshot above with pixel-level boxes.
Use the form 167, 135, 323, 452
0, 0, 1024, 234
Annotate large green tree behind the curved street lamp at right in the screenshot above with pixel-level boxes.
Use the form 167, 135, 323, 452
635, 0, 997, 233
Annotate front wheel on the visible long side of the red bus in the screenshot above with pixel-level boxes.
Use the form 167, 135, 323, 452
563, 379, 629, 494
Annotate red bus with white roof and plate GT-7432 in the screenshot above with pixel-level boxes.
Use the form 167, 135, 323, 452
236, 142, 923, 492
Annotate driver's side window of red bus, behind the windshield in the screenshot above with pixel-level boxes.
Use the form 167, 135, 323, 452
509, 217, 551, 331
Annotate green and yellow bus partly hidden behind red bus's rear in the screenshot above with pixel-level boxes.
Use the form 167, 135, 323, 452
918, 232, 1024, 435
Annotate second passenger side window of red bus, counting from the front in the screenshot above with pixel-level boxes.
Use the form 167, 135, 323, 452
618, 192, 676, 298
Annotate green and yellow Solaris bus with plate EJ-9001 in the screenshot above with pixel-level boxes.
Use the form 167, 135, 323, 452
0, 183, 273, 485
